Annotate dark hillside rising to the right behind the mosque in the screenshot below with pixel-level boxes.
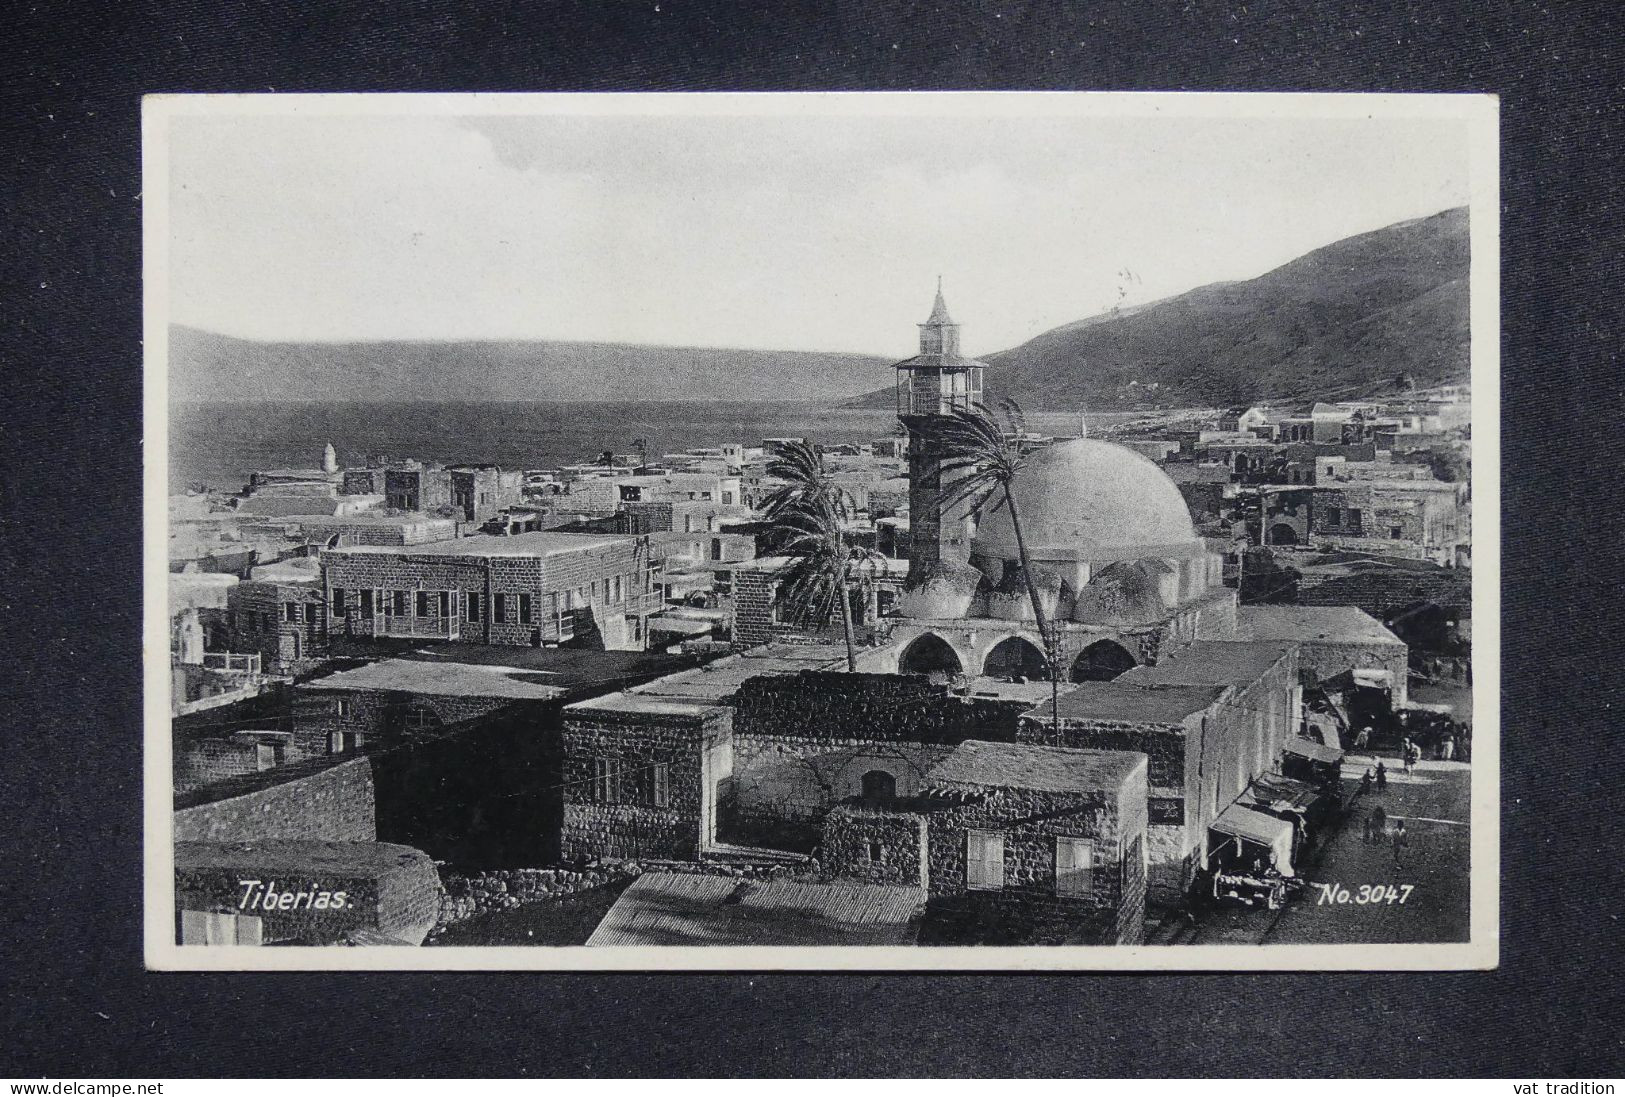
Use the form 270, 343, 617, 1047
861, 210, 1469, 411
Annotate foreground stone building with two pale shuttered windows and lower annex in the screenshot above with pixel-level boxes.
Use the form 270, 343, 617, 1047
822, 739, 1147, 944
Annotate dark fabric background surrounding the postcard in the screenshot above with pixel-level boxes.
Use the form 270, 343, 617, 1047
0, 0, 1625, 1077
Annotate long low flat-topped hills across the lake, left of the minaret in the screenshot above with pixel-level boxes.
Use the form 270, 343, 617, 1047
169, 325, 892, 409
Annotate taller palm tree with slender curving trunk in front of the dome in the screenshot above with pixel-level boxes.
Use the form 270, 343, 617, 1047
923, 398, 1061, 743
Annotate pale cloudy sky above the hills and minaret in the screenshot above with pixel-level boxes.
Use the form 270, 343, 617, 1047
167, 96, 1469, 358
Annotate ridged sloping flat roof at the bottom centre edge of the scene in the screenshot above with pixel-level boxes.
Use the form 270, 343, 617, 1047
587, 873, 926, 947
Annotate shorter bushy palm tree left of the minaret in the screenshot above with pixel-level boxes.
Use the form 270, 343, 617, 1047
762, 442, 863, 671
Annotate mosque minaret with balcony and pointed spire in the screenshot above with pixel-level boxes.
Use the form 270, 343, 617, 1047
897, 276, 983, 587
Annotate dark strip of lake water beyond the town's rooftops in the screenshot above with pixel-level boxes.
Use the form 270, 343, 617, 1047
169, 401, 1116, 491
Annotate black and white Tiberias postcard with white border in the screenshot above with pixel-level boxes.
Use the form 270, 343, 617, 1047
141, 93, 1500, 972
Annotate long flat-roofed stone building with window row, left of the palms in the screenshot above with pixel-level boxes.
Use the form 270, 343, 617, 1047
322, 531, 661, 650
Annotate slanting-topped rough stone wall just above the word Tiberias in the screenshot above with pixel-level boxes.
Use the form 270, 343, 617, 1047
174, 757, 379, 842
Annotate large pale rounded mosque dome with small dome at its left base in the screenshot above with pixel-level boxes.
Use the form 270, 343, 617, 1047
972, 439, 1201, 562
